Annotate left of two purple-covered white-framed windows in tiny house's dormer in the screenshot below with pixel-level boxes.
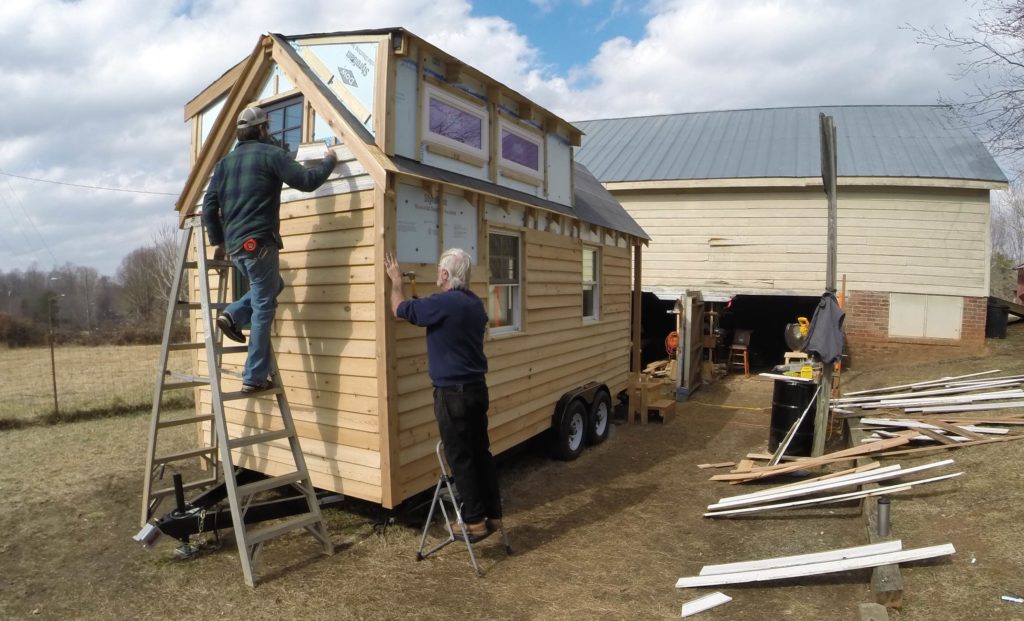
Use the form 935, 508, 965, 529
423, 84, 487, 162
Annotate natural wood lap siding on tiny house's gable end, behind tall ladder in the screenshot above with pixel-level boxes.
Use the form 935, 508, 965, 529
193, 187, 386, 502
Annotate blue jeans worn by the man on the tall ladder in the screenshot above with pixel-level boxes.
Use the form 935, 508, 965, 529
225, 244, 285, 385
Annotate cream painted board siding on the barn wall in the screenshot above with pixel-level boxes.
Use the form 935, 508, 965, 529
615, 188, 989, 296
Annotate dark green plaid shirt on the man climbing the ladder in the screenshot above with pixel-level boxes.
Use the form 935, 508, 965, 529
203, 140, 337, 255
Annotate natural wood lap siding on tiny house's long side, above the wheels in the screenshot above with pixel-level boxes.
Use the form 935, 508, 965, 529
395, 230, 630, 500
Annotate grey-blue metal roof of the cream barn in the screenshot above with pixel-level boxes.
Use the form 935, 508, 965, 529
573, 106, 1007, 182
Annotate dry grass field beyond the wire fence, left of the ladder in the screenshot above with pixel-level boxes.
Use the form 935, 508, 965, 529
0, 345, 190, 426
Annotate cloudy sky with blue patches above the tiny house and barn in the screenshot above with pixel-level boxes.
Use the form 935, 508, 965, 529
0, 0, 991, 276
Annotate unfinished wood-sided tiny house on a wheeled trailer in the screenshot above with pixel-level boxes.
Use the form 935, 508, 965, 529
177, 29, 648, 507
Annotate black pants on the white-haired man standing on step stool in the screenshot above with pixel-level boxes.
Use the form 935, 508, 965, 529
434, 381, 502, 524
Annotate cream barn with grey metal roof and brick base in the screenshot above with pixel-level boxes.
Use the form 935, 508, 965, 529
575, 106, 1008, 364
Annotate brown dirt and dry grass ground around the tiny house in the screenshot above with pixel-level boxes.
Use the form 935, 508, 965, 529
0, 324, 1024, 621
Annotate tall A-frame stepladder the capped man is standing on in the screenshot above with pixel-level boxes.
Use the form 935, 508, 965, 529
141, 216, 334, 586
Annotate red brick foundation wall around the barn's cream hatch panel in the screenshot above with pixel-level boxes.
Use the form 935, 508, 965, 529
844, 291, 988, 365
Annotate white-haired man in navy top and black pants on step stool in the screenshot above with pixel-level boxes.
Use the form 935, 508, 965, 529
384, 248, 502, 537
